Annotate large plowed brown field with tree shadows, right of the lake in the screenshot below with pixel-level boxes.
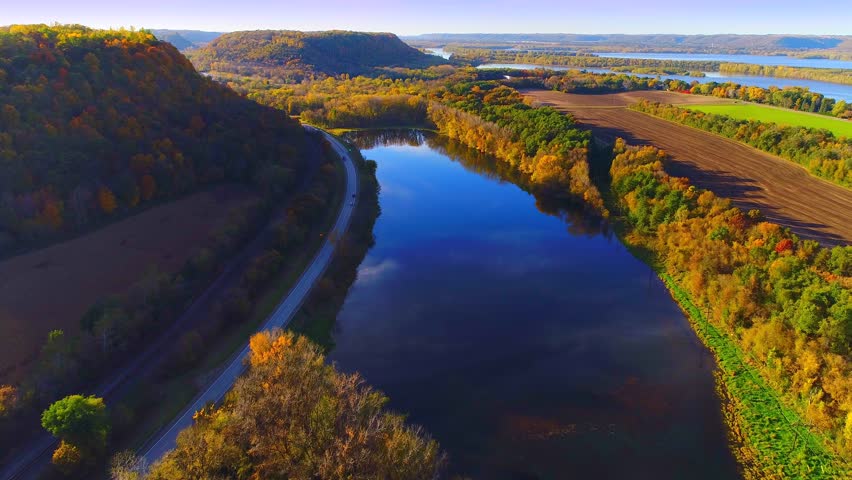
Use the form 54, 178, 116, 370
523, 90, 852, 245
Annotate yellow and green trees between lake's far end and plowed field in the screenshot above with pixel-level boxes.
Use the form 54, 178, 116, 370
429, 81, 607, 215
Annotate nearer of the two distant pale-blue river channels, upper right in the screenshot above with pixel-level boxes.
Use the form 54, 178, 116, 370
477, 63, 852, 103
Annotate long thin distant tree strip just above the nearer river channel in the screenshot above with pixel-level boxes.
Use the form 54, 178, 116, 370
445, 47, 720, 75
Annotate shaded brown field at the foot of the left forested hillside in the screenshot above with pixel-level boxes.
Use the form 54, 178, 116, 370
0, 186, 256, 381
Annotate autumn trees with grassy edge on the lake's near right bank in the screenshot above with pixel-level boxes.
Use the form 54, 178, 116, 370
611, 140, 852, 472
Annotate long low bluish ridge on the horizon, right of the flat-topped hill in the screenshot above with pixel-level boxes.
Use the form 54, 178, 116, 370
404, 33, 852, 53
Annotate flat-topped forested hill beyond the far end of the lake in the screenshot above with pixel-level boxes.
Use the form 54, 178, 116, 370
190, 30, 446, 76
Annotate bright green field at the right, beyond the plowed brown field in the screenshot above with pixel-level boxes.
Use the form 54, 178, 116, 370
689, 103, 852, 137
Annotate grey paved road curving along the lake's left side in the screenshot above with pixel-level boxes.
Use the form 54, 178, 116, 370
141, 125, 358, 465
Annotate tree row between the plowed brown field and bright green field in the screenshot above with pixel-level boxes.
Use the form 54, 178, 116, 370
630, 100, 852, 187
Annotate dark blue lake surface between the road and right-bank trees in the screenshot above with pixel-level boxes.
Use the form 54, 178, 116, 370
330, 132, 738, 480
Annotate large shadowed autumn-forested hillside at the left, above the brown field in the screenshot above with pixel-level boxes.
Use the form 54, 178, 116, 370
0, 25, 304, 253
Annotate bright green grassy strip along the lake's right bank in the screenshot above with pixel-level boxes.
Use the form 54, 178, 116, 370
658, 271, 850, 479
